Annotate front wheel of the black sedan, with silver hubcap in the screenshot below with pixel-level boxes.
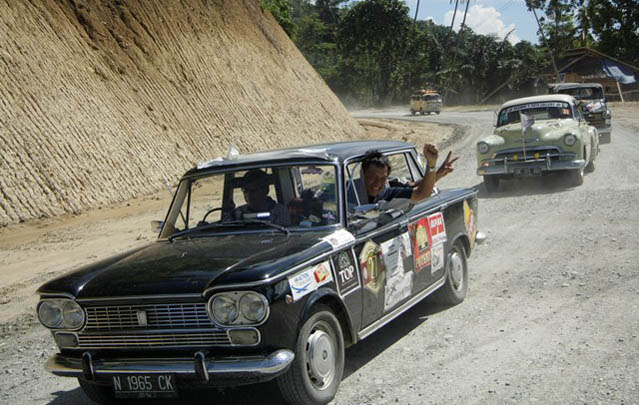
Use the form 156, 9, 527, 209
277, 305, 344, 405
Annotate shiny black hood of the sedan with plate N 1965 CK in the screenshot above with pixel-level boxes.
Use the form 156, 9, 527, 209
38, 231, 332, 298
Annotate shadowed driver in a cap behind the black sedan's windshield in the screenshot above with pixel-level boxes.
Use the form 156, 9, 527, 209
234, 169, 290, 226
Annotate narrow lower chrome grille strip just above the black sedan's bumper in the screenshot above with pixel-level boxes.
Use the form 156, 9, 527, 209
78, 329, 231, 349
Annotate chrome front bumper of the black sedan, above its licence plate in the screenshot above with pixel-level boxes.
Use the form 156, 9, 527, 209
45, 349, 295, 385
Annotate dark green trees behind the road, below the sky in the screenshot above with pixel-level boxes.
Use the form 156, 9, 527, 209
260, 0, 639, 106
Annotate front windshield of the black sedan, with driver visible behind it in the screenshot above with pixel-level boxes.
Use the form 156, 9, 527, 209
160, 164, 339, 239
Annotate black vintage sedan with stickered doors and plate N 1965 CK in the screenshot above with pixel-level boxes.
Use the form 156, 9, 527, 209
37, 141, 477, 404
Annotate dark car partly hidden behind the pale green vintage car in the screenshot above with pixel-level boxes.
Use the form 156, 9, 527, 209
548, 83, 612, 143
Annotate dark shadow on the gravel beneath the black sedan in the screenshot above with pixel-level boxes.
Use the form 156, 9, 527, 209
48, 299, 448, 405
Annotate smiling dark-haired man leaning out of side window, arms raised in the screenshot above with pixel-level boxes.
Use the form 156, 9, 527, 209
360, 144, 458, 204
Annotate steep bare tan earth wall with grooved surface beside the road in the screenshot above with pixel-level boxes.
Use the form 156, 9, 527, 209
0, 0, 362, 225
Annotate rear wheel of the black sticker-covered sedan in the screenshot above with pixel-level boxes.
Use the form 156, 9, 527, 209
433, 240, 468, 305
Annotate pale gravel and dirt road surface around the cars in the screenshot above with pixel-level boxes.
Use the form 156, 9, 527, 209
0, 104, 639, 404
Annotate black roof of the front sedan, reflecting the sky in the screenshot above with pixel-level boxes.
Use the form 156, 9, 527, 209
185, 140, 415, 176
